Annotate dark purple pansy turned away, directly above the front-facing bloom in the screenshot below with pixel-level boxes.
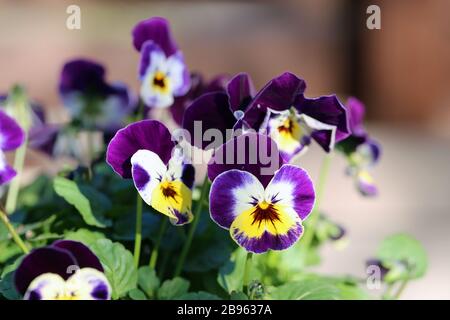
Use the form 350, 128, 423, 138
183, 73, 254, 150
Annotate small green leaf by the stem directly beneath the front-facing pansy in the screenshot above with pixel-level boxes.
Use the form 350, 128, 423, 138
217, 248, 247, 293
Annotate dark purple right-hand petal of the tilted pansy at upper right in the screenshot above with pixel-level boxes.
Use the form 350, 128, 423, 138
295, 95, 350, 145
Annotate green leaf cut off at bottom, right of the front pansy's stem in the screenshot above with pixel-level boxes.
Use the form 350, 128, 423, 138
270, 278, 340, 300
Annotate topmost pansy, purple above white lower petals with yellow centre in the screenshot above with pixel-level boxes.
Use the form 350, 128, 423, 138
133, 17, 190, 108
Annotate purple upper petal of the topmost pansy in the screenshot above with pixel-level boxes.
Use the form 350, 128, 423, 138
132, 17, 177, 57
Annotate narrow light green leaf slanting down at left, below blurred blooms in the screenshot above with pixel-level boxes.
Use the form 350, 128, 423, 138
53, 177, 107, 228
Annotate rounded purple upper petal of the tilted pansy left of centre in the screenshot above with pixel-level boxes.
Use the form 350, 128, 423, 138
106, 120, 175, 178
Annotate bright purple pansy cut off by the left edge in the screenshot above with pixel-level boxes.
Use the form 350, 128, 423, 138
0, 110, 25, 185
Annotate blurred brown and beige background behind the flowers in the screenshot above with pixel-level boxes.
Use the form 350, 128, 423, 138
0, 0, 450, 299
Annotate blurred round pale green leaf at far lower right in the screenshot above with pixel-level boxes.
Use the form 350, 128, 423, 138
377, 234, 428, 282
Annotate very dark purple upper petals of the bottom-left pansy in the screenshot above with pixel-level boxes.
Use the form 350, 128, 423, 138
14, 247, 78, 294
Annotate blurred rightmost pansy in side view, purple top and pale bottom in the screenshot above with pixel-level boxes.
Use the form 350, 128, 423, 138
337, 97, 381, 196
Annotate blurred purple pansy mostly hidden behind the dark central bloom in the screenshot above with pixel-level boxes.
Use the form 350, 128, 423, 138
170, 73, 228, 126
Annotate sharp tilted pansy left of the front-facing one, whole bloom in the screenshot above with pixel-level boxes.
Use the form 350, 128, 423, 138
106, 120, 195, 225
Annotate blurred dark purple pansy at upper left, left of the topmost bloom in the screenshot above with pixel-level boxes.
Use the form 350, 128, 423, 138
59, 59, 137, 132
